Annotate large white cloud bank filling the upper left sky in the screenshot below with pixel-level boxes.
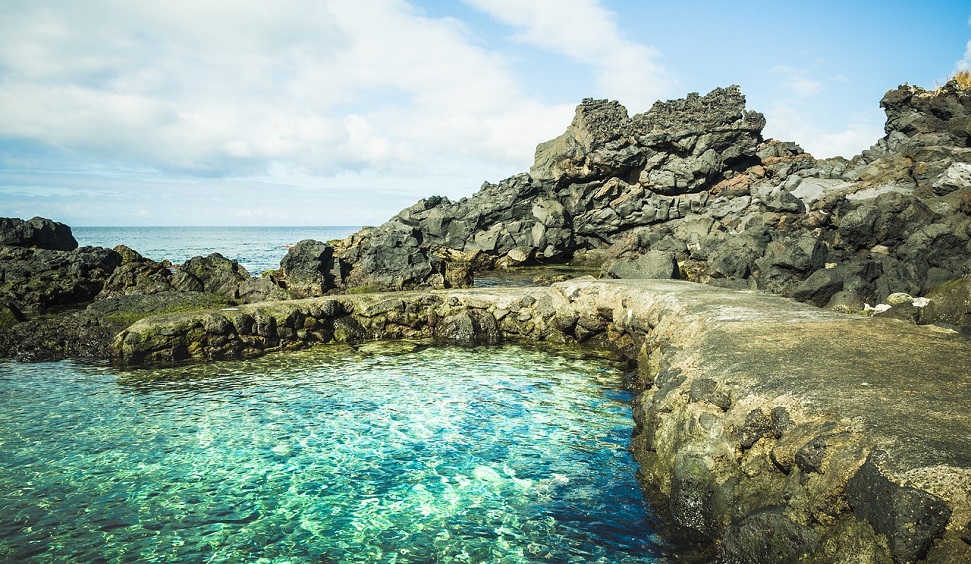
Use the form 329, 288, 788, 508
0, 0, 573, 180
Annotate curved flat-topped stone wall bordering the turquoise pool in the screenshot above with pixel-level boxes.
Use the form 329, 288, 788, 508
112, 280, 971, 562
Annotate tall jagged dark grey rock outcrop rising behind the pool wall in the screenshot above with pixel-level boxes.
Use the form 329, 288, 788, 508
336, 81, 971, 318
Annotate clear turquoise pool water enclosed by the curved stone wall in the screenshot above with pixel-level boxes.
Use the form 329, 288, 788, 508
0, 345, 665, 562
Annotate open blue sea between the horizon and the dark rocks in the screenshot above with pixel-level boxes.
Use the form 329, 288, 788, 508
71, 226, 360, 276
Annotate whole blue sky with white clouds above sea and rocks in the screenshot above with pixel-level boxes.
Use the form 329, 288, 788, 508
0, 0, 971, 226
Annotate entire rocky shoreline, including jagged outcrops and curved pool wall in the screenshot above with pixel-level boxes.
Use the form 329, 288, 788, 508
0, 81, 971, 562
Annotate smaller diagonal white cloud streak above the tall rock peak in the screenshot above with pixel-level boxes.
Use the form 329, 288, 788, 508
466, 0, 677, 112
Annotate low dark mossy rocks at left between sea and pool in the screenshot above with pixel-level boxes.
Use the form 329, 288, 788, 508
0, 228, 293, 361
